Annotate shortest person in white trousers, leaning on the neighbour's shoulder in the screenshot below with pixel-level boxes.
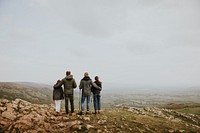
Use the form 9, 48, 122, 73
53, 80, 64, 112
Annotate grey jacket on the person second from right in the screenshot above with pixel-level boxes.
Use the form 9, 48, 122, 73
79, 77, 100, 96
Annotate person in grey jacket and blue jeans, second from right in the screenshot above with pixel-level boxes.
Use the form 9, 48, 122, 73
79, 72, 99, 115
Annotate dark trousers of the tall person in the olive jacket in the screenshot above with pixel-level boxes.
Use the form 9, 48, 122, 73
65, 94, 74, 114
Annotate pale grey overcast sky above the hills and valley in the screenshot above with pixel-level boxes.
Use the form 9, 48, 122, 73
0, 0, 200, 86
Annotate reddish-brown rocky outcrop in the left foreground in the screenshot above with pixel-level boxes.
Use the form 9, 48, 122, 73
0, 99, 104, 132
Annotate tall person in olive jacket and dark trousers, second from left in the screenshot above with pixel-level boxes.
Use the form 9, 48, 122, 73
54, 71, 77, 114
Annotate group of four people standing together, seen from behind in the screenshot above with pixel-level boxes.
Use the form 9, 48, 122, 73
53, 71, 102, 115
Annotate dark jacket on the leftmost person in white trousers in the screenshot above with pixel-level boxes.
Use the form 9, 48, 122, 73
53, 84, 64, 100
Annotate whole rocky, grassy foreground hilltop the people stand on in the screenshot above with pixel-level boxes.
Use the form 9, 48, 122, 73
0, 99, 200, 133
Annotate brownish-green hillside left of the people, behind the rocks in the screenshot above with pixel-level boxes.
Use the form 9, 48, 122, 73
0, 82, 53, 104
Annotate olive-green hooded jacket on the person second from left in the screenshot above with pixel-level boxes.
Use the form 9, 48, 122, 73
54, 75, 77, 95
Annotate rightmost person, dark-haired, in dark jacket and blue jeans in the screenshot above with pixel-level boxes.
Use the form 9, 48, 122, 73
92, 76, 102, 114
